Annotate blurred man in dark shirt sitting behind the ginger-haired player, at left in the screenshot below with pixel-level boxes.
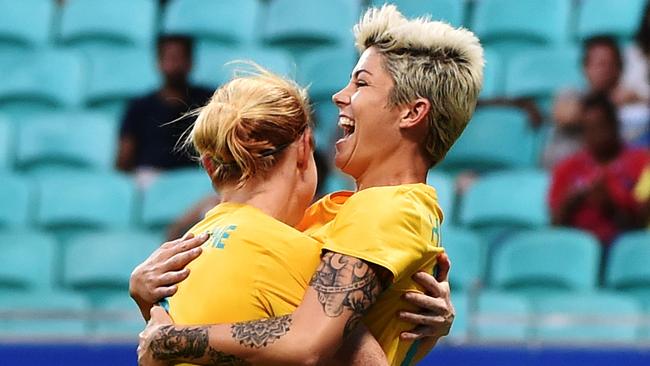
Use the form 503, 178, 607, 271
117, 35, 212, 187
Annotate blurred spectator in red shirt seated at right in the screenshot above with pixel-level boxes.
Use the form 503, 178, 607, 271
549, 94, 650, 245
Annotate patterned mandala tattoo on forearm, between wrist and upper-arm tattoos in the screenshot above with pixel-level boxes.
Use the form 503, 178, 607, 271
230, 314, 292, 348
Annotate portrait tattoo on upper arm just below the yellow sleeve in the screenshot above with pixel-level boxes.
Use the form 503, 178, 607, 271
310, 252, 382, 336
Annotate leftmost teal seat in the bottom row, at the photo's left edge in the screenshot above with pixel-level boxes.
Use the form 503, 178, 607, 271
0, 292, 89, 341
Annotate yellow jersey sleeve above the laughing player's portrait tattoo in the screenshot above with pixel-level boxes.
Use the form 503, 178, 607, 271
323, 189, 442, 282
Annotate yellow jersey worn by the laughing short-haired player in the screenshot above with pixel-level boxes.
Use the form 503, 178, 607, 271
297, 184, 443, 365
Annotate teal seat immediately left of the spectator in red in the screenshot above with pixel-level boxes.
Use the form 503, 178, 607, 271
460, 170, 549, 229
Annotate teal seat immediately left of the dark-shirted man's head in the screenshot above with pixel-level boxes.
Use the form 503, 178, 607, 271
86, 47, 160, 118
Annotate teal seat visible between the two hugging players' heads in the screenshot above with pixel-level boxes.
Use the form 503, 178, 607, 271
298, 47, 357, 151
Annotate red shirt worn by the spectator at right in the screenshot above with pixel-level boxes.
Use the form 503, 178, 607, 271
549, 148, 650, 243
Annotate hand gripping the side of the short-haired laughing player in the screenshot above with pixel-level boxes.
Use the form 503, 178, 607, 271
399, 253, 456, 342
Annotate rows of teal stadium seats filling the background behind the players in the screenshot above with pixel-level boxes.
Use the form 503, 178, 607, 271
0, 0, 650, 365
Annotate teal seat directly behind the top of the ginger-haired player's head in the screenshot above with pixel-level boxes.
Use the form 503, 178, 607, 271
192, 43, 295, 88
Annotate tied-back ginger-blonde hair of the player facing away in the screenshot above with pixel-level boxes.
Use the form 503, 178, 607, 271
185, 63, 311, 187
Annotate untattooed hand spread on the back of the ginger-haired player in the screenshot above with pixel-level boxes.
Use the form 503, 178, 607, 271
129, 233, 209, 317
